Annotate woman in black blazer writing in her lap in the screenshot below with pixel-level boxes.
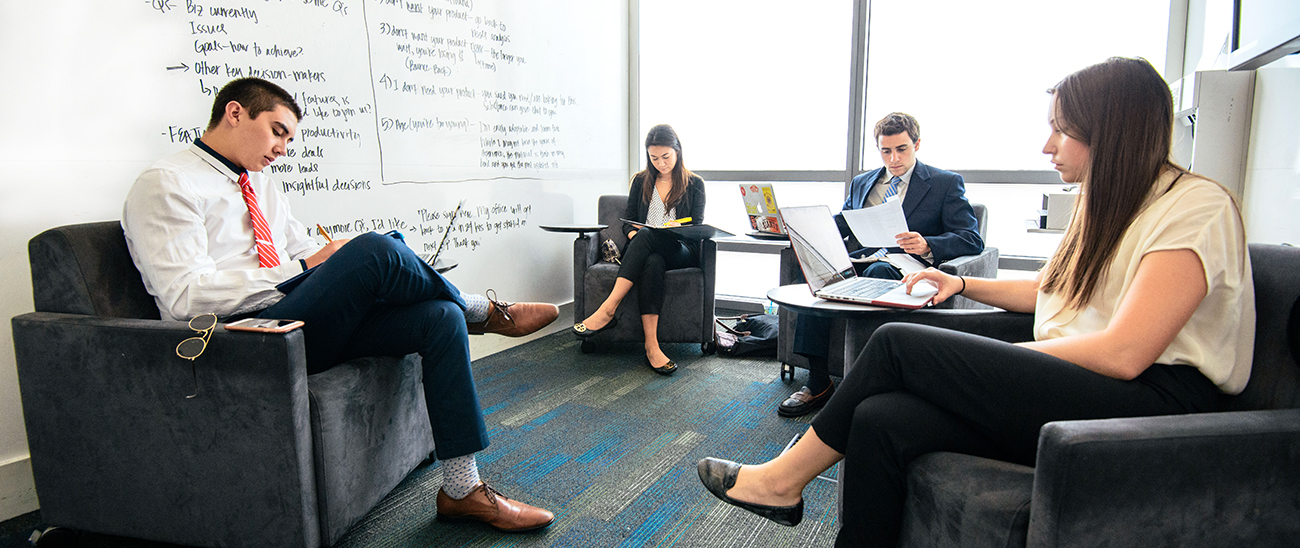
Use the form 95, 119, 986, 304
573, 123, 705, 375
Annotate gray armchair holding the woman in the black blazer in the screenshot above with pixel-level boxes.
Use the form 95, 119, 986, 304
573, 195, 718, 353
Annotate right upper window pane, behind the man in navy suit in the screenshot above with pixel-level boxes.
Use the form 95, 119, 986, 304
861, 0, 1169, 171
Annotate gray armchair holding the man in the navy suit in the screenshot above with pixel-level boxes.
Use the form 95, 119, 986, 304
776, 204, 998, 378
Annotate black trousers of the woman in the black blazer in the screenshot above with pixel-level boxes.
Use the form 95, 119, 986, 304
619, 229, 696, 316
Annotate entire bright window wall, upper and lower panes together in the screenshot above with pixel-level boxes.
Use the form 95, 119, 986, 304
632, 0, 1182, 297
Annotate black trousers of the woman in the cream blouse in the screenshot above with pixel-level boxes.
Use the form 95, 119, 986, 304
813, 323, 1219, 547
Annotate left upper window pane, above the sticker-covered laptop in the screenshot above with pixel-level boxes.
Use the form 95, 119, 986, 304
633, 0, 853, 170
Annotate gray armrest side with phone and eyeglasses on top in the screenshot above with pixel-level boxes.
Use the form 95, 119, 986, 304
12, 313, 320, 547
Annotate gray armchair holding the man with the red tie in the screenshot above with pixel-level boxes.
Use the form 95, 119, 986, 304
13, 221, 433, 547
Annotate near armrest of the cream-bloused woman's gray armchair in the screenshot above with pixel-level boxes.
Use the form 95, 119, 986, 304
1028, 409, 1300, 547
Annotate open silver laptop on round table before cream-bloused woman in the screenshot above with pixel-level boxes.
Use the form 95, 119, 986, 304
781, 205, 936, 309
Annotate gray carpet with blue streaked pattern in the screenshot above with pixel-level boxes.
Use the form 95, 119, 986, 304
0, 332, 839, 548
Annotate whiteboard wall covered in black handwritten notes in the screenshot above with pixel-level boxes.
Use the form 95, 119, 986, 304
0, 0, 628, 306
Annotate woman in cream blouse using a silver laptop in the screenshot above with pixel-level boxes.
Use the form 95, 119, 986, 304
698, 58, 1255, 547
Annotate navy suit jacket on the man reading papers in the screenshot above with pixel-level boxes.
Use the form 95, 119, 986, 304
835, 161, 984, 265
